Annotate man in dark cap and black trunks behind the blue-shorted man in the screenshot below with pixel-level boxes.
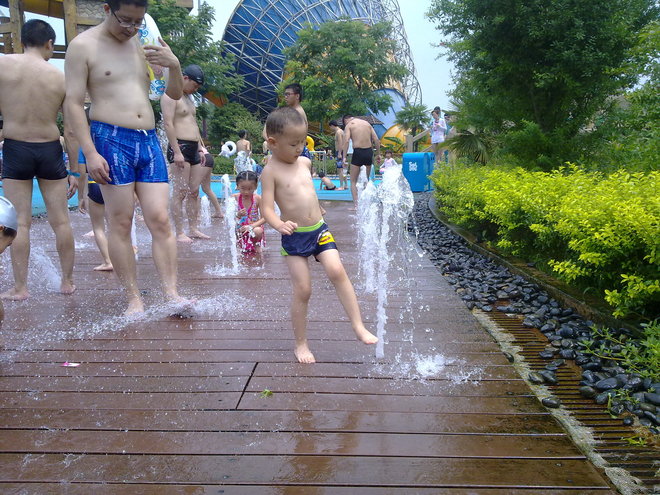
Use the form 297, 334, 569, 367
160, 65, 210, 243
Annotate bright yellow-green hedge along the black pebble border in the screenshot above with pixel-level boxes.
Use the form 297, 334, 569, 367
432, 165, 660, 318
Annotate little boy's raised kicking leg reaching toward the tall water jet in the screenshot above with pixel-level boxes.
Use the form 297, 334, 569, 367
317, 249, 378, 344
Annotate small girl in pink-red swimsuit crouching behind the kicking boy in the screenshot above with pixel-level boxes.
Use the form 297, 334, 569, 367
233, 170, 266, 254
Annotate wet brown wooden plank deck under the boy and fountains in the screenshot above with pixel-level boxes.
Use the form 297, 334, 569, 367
0, 202, 615, 495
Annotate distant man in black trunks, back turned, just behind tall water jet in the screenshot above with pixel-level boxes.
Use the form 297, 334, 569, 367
343, 115, 380, 207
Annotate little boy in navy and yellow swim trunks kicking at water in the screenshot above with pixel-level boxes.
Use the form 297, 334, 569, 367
261, 107, 378, 363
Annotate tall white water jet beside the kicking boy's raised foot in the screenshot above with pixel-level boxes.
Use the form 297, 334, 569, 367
358, 166, 415, 358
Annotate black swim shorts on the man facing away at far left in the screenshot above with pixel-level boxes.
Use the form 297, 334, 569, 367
2, 139, 67, 180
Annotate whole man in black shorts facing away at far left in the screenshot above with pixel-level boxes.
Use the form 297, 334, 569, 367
0, 19, 77, 300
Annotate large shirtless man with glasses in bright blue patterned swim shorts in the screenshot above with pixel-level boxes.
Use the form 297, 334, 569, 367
65, 0, 190, 315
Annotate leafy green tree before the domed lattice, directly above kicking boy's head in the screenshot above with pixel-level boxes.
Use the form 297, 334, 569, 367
282, 19, 407, 126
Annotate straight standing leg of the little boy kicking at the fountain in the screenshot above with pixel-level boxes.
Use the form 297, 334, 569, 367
286, 256, 316, 363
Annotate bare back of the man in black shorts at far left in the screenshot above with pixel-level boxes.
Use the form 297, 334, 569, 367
0, 54, 64, 143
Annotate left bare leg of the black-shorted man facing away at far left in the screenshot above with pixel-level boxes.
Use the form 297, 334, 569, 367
0, 179, 32, 301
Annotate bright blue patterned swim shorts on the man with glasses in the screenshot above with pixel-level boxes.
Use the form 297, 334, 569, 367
90, 120, 167, 186
